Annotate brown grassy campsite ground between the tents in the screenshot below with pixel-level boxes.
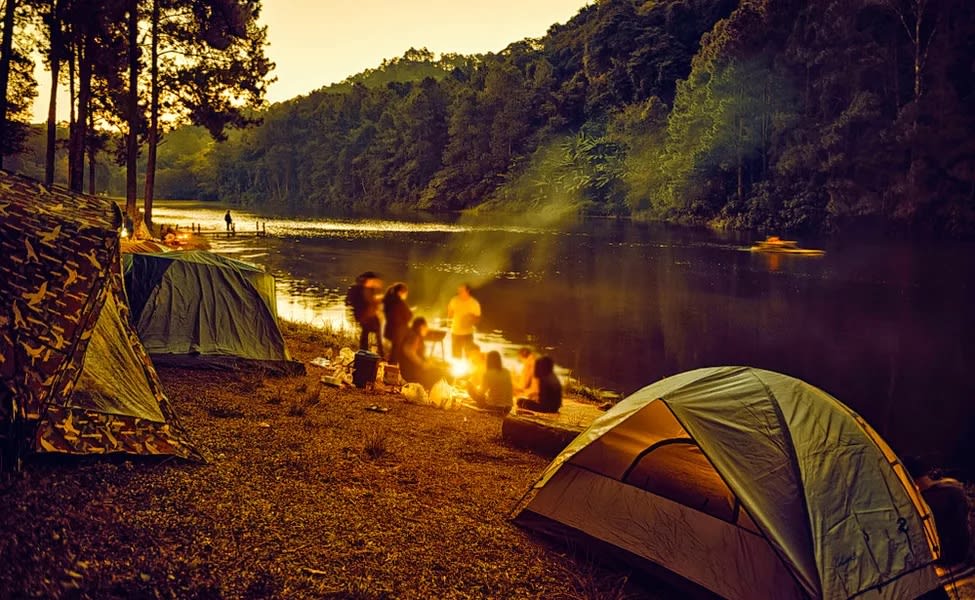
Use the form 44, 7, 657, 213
0, 326, 673, 598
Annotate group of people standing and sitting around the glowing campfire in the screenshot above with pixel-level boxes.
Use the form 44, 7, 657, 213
345, 271, 562, 413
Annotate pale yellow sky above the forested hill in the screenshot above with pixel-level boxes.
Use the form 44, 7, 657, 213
34, 0, 591, 123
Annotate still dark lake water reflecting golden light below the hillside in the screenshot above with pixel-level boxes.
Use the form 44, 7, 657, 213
149, 202, 975, 460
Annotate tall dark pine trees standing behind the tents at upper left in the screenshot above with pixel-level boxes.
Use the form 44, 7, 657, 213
0, 0, 274, 224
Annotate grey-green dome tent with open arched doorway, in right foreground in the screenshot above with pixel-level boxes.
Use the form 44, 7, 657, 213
514, 367, 939, 599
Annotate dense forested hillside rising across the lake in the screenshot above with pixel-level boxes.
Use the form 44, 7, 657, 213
1, 0, 975, 237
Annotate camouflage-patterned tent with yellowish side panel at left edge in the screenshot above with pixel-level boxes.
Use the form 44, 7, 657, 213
0, 171, 199, 468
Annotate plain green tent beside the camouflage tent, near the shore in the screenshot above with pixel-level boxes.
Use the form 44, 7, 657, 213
124, 250, 304, 373
